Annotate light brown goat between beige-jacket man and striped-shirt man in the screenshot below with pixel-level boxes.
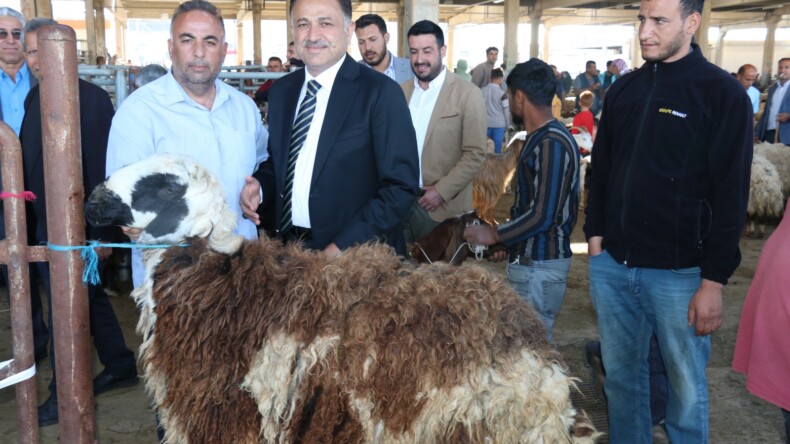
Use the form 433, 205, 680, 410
472, 132, 526, 225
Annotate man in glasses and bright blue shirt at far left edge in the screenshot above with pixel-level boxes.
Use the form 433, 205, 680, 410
0, 6, 35, 136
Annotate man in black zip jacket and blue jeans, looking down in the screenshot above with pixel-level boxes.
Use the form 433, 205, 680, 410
584, 0, 752, 443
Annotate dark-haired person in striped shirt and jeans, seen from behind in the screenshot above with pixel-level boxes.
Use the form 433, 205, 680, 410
464, 58, 579, 339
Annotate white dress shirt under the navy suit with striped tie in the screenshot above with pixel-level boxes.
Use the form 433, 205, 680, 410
289, 56, 346, 228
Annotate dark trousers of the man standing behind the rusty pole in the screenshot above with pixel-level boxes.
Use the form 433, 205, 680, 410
39, 261, 136, 397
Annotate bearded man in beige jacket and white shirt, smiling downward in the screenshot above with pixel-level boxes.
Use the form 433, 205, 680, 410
401, 20, 488, 242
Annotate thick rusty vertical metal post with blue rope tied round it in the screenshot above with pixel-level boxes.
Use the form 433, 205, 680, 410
38, 25, 95, 444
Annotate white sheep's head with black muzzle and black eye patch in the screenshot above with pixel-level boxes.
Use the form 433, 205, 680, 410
85, 154, 241, 253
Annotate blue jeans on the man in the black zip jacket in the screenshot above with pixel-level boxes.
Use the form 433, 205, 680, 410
590, 251, 710, 444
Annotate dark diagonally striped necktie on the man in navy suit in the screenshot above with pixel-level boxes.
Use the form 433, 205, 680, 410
280, 80, 321, 234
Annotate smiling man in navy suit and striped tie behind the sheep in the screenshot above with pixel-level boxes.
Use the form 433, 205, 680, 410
241, 0, 419, 255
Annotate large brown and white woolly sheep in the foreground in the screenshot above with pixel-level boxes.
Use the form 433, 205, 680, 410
85, 155, 596, 443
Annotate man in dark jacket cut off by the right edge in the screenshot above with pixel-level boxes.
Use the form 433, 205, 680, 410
755, 57, 790, 145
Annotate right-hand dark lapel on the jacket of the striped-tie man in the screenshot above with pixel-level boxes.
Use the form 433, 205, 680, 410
311, 54, 360, 183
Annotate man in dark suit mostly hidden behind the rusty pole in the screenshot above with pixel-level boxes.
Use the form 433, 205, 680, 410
20, 19, 137, 426
